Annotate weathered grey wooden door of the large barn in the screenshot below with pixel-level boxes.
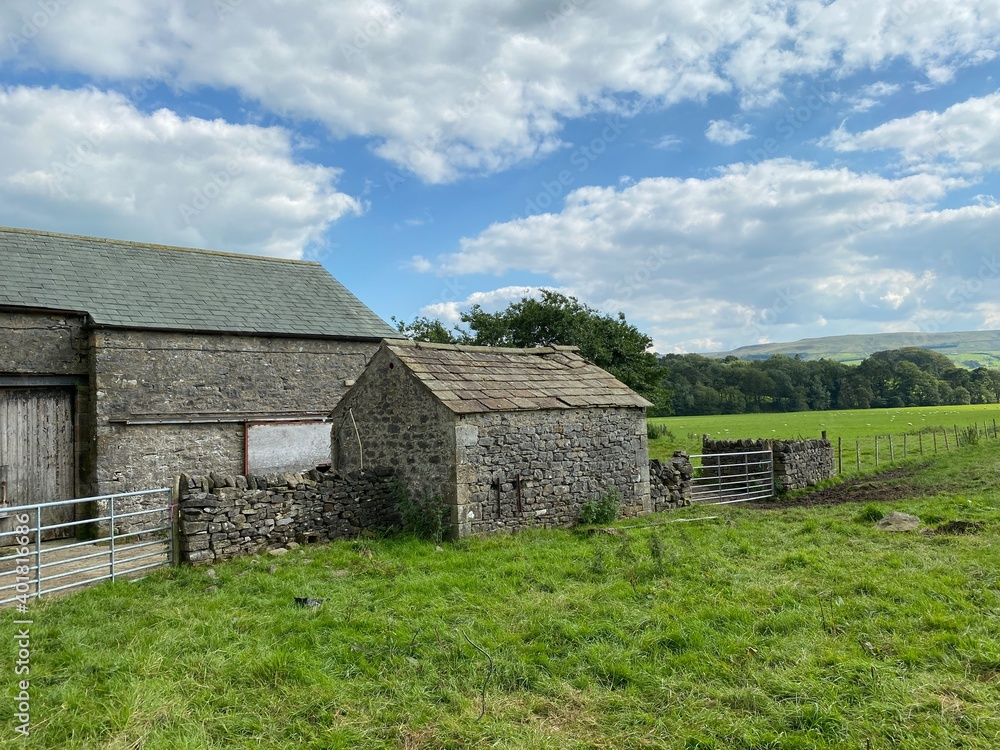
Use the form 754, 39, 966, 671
0, 388, 76, 544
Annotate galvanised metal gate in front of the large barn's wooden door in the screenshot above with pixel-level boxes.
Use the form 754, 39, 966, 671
0, 488, 177, 609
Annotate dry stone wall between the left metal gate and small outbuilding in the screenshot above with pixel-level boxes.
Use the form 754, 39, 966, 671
178, 469, 399, 563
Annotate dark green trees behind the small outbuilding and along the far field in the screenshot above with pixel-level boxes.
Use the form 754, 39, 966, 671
393, 290, 1000, 416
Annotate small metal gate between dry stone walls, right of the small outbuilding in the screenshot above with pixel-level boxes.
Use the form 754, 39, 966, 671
691, 451, 774, 505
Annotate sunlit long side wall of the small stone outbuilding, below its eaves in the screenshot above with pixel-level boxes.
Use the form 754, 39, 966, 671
456, 408, 651, 535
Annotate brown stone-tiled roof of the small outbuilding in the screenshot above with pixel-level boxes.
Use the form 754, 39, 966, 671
384, 340, 652, 414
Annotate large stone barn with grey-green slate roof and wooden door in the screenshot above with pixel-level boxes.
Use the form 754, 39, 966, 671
0, 228, 398, 528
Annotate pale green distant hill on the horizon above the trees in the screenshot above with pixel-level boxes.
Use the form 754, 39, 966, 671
705, 331, 1000, 369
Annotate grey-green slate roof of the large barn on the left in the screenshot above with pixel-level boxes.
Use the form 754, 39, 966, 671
0, 227, 399, 339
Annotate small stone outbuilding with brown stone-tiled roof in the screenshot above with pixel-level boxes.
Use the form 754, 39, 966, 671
331, 340, 651, 536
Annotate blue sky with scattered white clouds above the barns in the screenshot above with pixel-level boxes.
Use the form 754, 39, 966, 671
0, 0, 1000, 353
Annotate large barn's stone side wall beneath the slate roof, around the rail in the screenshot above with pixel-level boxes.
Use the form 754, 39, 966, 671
91, 329, 377, 512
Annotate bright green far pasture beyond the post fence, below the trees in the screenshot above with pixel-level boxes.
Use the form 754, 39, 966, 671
649, 404, 1000, 473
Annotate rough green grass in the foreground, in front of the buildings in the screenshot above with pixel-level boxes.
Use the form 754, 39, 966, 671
0, 442, 1000, 750
